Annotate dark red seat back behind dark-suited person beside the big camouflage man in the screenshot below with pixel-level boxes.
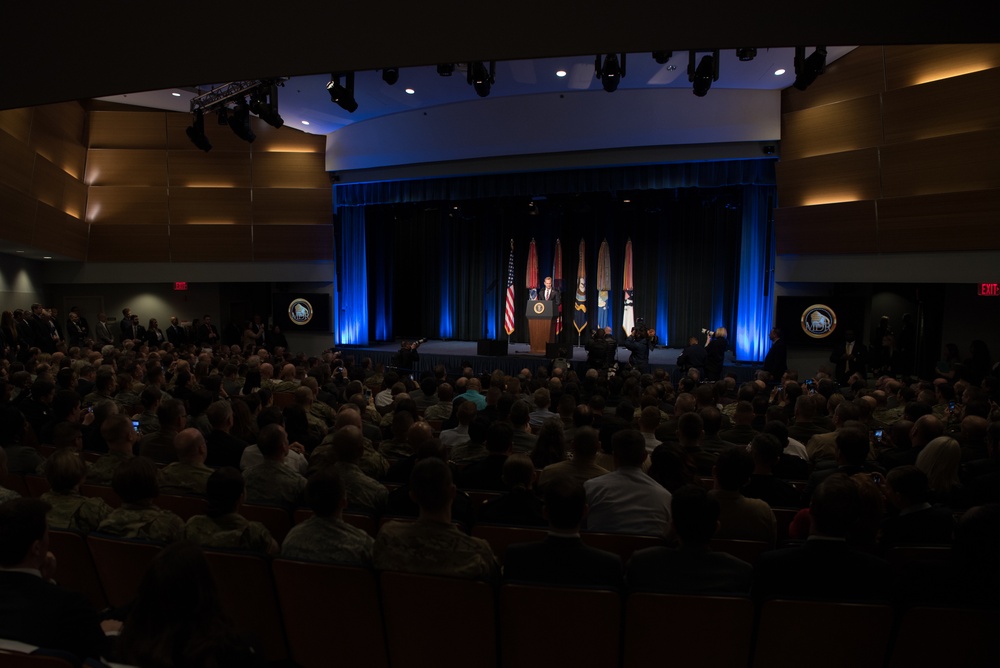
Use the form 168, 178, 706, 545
500, 584, 621, 668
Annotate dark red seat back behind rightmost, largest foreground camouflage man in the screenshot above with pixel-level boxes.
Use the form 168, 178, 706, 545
380, 571, 497, 668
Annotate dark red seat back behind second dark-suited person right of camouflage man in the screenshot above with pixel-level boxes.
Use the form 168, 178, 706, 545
623, 592, 752, 668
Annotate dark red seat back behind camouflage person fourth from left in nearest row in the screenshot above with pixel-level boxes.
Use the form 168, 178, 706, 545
271, 559, 389, 668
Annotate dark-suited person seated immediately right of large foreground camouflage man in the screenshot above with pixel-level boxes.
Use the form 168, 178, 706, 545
503, 477, 622, 589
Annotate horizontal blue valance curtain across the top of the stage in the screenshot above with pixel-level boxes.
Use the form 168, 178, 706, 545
333, 158, 775, 206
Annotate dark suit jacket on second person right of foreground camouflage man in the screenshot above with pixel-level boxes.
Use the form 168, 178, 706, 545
625, 546, 753, 595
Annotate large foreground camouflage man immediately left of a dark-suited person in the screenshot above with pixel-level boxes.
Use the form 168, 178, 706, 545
373, 457, 499, 580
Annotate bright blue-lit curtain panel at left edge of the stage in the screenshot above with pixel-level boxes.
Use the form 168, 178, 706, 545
334, 206, 368, 345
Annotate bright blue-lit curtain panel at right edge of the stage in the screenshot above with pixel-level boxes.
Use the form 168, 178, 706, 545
736, 187, 774, 362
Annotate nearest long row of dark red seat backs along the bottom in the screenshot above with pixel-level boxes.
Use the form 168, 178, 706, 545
39, 531, 1000, 668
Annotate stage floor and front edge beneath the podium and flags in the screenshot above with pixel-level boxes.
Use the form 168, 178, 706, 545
339, 340, 759, 382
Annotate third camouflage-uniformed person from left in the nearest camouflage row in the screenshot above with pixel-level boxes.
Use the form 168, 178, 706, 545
184, 466, 279, 555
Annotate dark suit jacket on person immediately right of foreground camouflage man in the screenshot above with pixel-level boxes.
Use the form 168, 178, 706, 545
503, 535, 622, 589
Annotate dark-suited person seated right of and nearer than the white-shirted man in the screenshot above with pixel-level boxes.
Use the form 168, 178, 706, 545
625, 485, 753, 596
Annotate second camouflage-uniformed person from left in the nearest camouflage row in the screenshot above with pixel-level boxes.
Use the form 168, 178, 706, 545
97, 457, 184, 543
